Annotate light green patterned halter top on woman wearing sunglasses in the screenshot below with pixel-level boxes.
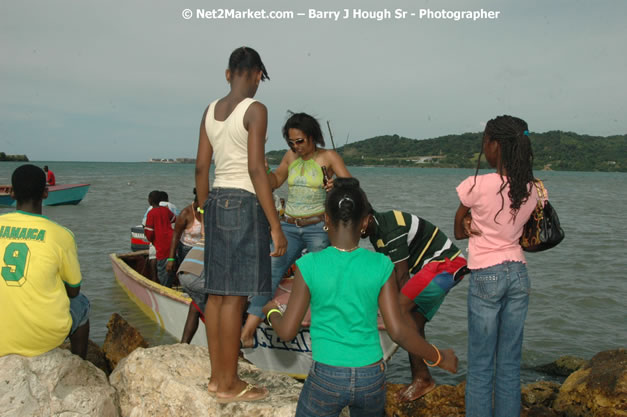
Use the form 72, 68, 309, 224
285, 154, 327, 217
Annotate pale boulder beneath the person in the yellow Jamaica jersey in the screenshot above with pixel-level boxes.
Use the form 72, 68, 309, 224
0, 349, 119, 417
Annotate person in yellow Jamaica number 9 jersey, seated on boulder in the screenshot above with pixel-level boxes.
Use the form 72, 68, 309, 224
0, 165, 90, 359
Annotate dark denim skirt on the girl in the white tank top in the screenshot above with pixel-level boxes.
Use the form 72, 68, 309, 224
204, 188, 271, 296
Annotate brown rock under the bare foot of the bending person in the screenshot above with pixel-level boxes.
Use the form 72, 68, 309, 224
385, 382, 466, 417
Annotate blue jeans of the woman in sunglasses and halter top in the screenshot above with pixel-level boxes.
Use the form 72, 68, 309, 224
248, 222, 330, 318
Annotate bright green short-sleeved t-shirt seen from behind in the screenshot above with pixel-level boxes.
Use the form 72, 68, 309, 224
296, 246, 394, 367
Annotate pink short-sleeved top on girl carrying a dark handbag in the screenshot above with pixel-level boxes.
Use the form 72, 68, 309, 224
457, 173, 538, 269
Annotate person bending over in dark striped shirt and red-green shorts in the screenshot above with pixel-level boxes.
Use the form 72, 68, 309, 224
361, 207, 469, 401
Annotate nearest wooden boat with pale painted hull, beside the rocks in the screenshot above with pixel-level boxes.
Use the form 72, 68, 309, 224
109, 251, 398, 378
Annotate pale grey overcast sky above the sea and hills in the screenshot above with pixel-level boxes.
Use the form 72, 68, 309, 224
0, 0, 627, 161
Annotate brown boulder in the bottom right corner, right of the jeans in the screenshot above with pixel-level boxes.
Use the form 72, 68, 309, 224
553, 349, 627, 417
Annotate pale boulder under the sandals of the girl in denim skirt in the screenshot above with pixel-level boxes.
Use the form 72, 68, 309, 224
109, 344, 302, 417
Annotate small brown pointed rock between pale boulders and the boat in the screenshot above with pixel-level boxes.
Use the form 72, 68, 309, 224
102, 313, 148, 369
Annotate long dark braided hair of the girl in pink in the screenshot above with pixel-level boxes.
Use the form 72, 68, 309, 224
473, 115, 534, 221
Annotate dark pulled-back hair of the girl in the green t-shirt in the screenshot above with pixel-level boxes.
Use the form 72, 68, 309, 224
325, 178, 369, 227
